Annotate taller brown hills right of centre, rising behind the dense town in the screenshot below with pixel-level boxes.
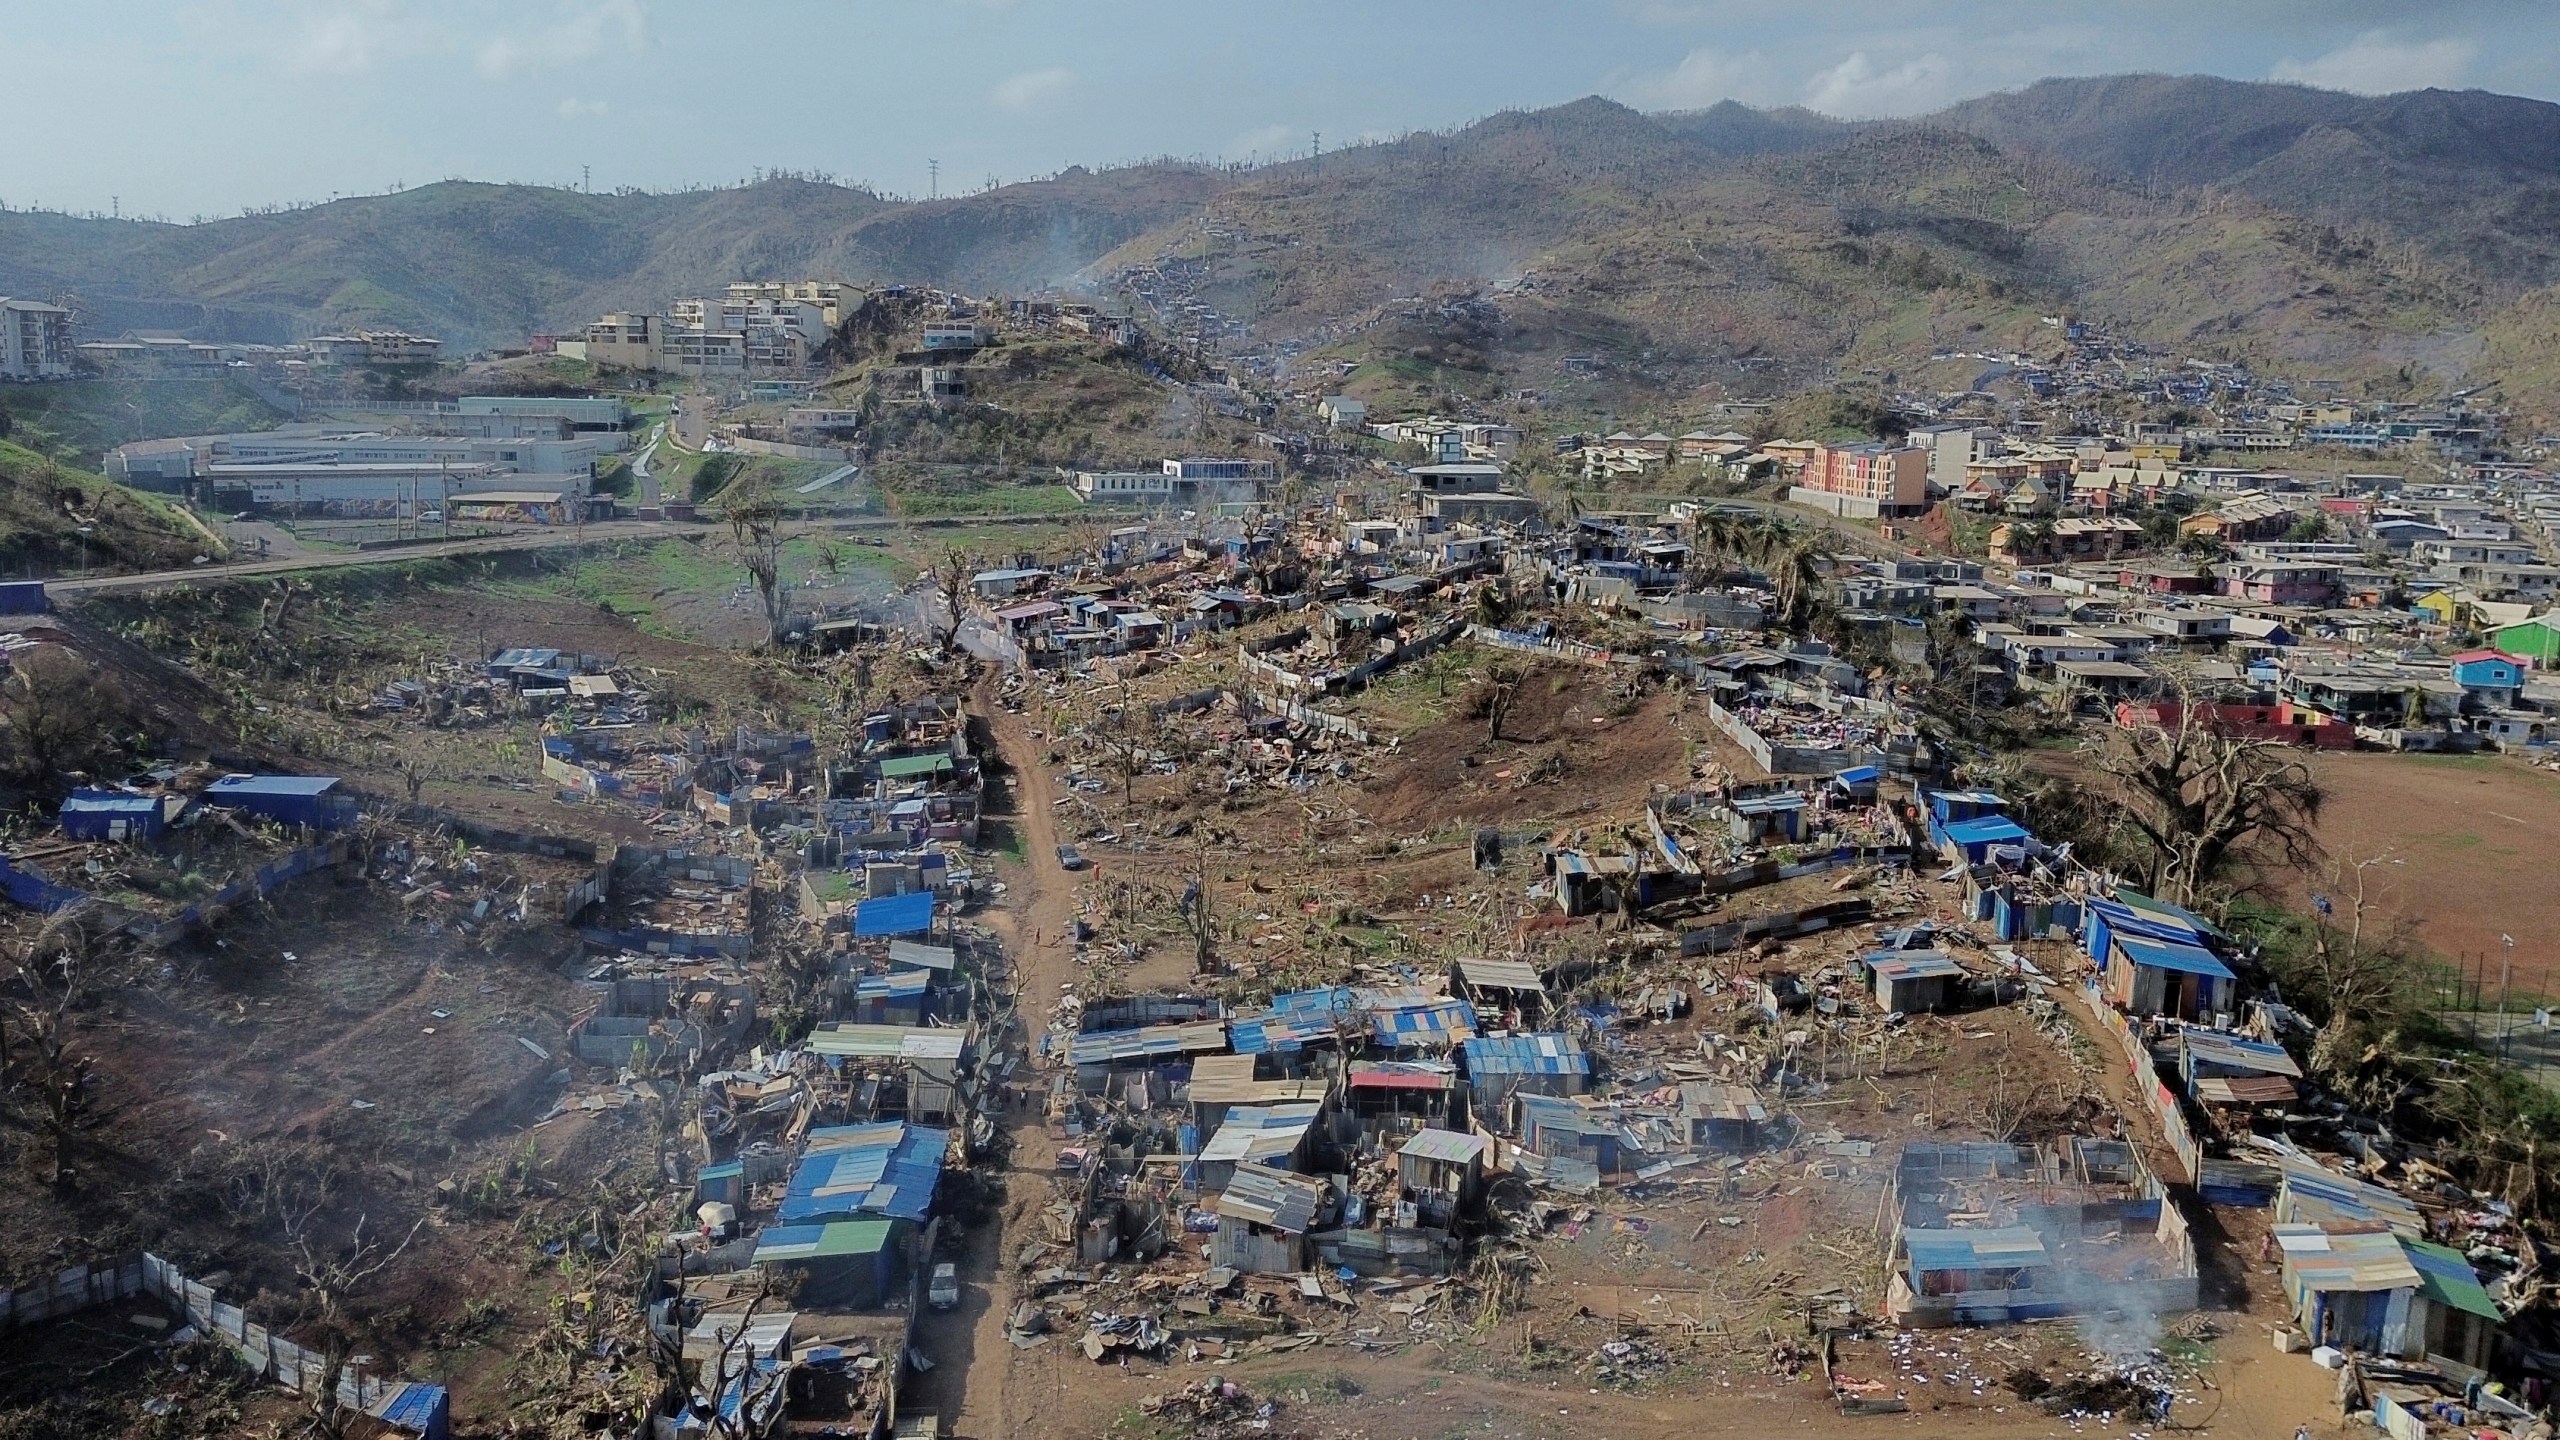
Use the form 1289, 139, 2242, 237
1103, 100, 2476, 410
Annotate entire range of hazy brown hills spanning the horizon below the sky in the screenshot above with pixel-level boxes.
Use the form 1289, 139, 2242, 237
15, 77, 2560, 415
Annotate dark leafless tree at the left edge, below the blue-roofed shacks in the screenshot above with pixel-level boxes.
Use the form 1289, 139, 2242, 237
0, 902, 115, 1186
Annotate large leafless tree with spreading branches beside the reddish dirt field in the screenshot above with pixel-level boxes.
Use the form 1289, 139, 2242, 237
2097, 676, 2322, 904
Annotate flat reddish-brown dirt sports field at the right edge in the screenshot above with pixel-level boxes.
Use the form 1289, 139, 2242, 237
2309, 753, 2560, 994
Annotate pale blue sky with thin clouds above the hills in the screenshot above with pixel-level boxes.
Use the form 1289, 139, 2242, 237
0, 0, 2560, 220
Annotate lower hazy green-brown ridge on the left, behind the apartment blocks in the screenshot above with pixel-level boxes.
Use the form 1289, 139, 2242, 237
0, 167, 1224, 348
